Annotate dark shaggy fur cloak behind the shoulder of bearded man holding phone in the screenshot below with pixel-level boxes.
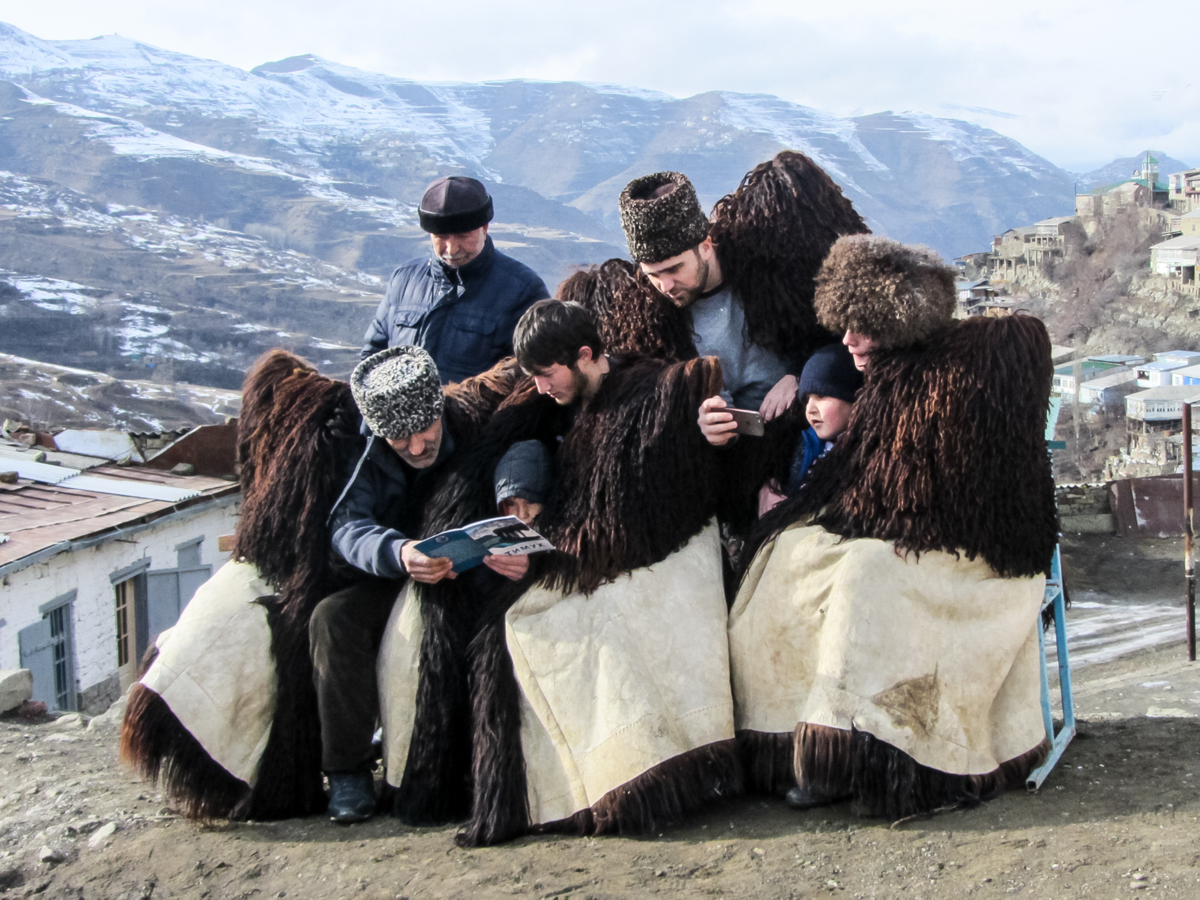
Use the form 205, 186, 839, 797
709, 150, 870, 360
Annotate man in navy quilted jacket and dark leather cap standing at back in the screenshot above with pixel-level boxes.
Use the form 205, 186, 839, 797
362, 175, 550, 384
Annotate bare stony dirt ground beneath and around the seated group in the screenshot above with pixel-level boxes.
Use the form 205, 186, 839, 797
0, 539, 1200, 900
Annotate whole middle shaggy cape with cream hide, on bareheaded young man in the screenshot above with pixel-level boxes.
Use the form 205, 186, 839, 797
379, 359, 739, 845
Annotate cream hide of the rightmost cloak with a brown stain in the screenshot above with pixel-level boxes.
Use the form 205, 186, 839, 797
730, 526, 1045, 775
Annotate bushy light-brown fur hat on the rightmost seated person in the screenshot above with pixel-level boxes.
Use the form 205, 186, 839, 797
815, 234, 955, 347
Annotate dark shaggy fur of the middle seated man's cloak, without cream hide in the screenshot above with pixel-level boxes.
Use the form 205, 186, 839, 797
384, 359, 740, 846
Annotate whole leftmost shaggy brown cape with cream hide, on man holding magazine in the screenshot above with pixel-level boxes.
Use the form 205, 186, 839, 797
120, 350, 516, 820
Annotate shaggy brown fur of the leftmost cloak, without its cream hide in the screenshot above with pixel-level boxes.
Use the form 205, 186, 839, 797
120, 349, 518, 820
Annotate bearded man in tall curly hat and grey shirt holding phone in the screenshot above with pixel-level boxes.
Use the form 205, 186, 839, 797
620, 172, 797, 420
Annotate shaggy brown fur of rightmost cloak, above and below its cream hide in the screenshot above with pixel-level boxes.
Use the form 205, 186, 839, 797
738, 316, 1058, 818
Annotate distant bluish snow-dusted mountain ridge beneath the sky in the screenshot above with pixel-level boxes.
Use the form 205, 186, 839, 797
0, 24, 1072, 267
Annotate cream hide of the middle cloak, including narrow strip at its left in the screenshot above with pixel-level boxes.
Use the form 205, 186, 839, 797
378, 524, 733, 824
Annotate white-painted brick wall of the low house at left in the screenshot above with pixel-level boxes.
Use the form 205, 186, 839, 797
0, 496, 241, 712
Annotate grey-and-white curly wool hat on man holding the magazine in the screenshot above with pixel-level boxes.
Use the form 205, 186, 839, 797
350, 347, 444, 440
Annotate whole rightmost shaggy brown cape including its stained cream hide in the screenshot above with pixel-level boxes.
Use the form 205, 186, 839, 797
730, 317, 1057, 818
